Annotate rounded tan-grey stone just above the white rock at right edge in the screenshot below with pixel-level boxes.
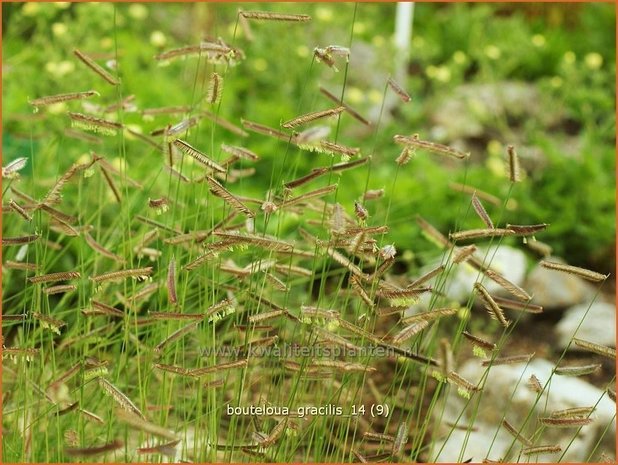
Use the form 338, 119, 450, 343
525, 257, 596, 310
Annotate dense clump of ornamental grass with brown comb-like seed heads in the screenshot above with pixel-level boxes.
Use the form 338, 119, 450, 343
2, 3, 615, 462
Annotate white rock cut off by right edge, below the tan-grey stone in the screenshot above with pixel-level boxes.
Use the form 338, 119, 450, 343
556, 302, 616, 350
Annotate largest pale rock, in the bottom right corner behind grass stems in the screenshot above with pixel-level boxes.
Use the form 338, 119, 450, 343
425, 359, 616, 462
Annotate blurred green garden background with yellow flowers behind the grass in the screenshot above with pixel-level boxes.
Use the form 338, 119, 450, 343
2, 2, 616, 272
